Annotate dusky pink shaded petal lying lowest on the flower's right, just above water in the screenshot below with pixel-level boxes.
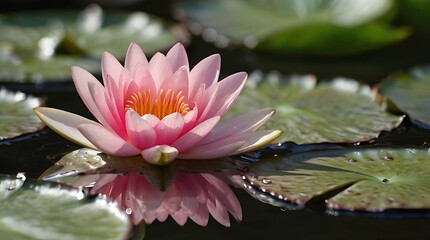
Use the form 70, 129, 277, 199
178, 141, 245, 159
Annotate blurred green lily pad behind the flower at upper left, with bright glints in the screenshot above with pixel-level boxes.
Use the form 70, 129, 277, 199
0, 5, 187, 82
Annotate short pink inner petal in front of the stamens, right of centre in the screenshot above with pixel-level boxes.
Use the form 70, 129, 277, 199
154, 112, 184, 145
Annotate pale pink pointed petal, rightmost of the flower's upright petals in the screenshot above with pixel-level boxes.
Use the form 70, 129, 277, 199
202, 72, 247, 120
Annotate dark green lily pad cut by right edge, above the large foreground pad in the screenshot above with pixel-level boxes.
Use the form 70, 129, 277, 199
378, 66, 430, 128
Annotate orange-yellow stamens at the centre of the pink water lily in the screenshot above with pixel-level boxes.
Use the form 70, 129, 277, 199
125, 89, 190, 119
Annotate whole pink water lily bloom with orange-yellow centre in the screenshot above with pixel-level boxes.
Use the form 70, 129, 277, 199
35, 43, 281, 165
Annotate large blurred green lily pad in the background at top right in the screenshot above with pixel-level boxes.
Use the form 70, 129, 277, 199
178, 0, 409, 55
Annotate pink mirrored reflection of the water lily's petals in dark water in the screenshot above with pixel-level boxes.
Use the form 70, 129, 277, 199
85, 173, 242, 226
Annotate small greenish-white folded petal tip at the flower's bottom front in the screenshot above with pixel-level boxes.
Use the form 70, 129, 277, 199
141, 145, 178, 165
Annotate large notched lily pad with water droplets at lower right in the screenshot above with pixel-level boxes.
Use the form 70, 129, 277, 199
246, 148, 430, 212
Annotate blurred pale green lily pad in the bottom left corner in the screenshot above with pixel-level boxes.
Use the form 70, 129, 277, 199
0, 175, 129, 240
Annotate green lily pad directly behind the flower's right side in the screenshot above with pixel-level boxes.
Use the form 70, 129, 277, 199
229, 72, 403, 144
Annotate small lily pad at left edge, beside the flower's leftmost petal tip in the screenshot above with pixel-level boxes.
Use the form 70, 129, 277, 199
0, 88, 44, 140
